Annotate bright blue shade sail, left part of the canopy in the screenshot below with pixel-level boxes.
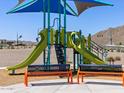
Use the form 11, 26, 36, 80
8, 0, 73, 15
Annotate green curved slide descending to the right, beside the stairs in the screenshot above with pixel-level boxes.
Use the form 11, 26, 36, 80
69, 32, 106, 64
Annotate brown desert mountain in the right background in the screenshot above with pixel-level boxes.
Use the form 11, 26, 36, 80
92, 26, 124, 46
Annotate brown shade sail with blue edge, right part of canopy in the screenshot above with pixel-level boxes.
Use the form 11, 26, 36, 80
69, 0, 113, 15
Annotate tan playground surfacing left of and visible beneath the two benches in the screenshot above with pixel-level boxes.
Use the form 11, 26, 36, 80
0, 69, 121, 86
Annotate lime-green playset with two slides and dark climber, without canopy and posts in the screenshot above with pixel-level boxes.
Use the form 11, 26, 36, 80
8, 28, 105, 70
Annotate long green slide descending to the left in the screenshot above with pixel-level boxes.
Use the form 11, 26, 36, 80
7, 29, 48, 70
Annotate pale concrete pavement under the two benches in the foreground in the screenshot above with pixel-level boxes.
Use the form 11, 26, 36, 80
0, 79, 124, 93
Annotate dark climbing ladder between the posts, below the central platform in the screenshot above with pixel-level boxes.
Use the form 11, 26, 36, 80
54, 44, 64, 64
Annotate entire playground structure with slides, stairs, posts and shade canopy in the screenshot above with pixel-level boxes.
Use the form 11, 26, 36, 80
7, 0, 112, 71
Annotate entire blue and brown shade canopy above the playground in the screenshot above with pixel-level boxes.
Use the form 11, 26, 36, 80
8, 0, 112, 15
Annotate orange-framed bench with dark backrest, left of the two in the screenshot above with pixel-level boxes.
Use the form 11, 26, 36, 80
24, 64, 73, 86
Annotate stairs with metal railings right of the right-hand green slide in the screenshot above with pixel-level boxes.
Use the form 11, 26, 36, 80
90, 41, 107, 60
